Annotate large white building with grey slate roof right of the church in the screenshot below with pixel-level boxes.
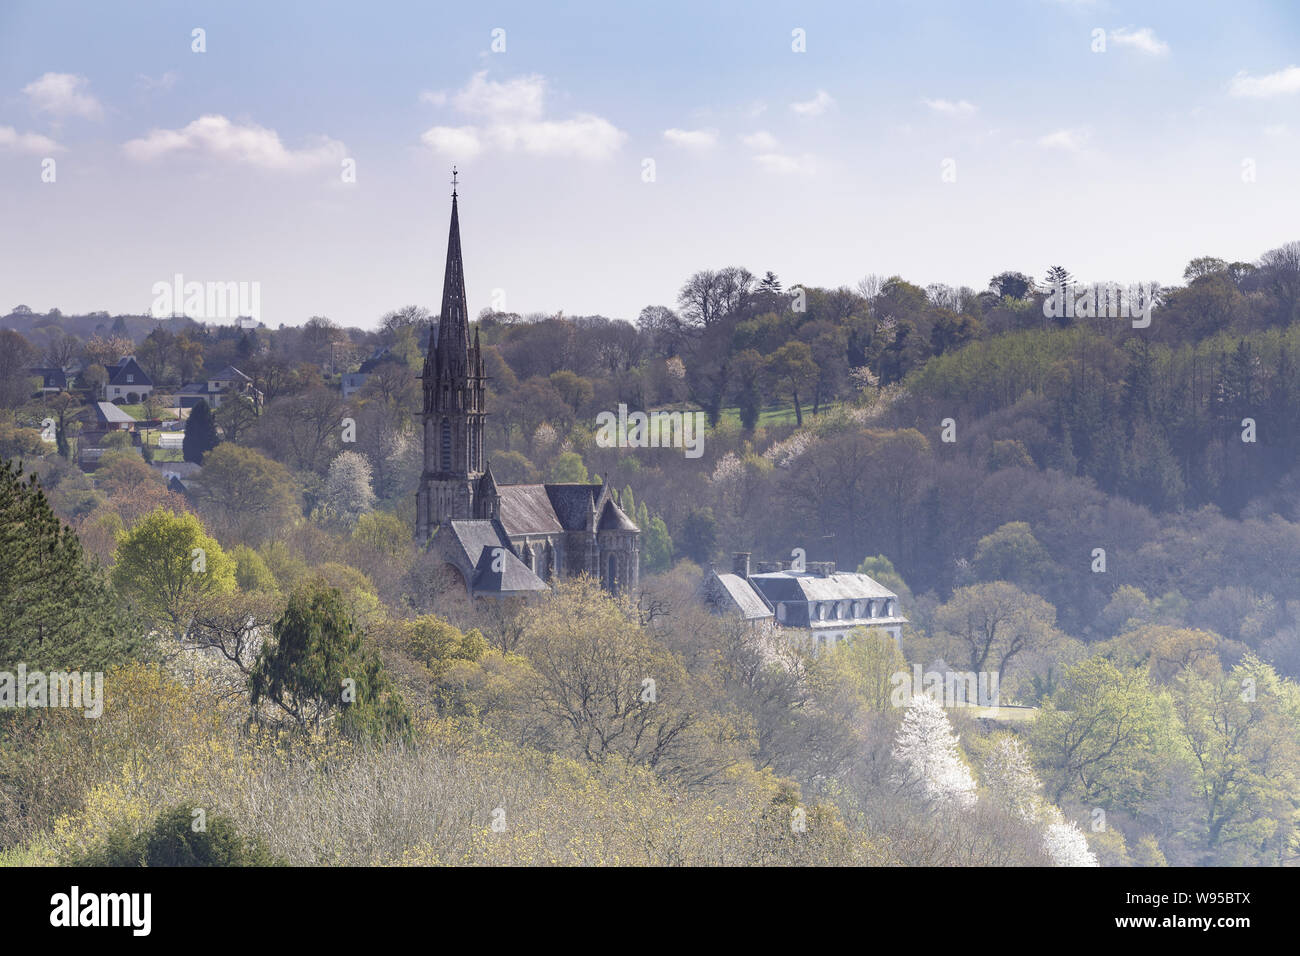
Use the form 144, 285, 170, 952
702, 551, 907, 649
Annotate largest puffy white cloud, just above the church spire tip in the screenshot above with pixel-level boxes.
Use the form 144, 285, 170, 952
420, 70, 628, 160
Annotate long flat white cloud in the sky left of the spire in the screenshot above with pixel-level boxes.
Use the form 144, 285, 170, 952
122, 116, 347, 170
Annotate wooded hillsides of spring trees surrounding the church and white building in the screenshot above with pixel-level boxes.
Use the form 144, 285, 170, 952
0, 242, 1300, 866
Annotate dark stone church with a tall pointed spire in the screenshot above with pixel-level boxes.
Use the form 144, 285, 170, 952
415, 181, 641, 598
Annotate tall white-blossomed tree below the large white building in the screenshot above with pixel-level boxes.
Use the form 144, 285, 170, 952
891, 693, 975, 809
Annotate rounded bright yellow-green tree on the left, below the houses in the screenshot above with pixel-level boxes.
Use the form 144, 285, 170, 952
113, 509, 235, 639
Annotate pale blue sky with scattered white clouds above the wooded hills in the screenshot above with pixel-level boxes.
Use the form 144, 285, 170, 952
0, 0, 1300, 328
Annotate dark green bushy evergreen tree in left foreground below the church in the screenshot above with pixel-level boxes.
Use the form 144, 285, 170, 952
250, 581, 411, 740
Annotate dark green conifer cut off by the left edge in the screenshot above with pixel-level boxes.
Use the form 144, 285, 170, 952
0, 462, 143, 670
